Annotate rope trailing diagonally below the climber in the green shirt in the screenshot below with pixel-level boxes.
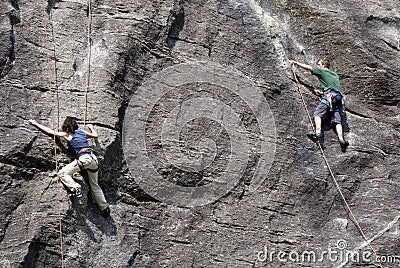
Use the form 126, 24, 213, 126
292, 64, 382, 268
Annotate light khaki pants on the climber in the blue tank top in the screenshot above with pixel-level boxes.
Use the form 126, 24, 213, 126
58, 154, 108, 210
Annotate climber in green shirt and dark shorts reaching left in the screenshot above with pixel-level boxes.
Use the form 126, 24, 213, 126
290, 59, 349, 152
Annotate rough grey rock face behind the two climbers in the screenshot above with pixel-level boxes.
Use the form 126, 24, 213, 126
0, 0, 400, 267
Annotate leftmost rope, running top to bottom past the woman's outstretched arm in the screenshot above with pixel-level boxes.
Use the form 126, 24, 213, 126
42, 0, 64, 268
